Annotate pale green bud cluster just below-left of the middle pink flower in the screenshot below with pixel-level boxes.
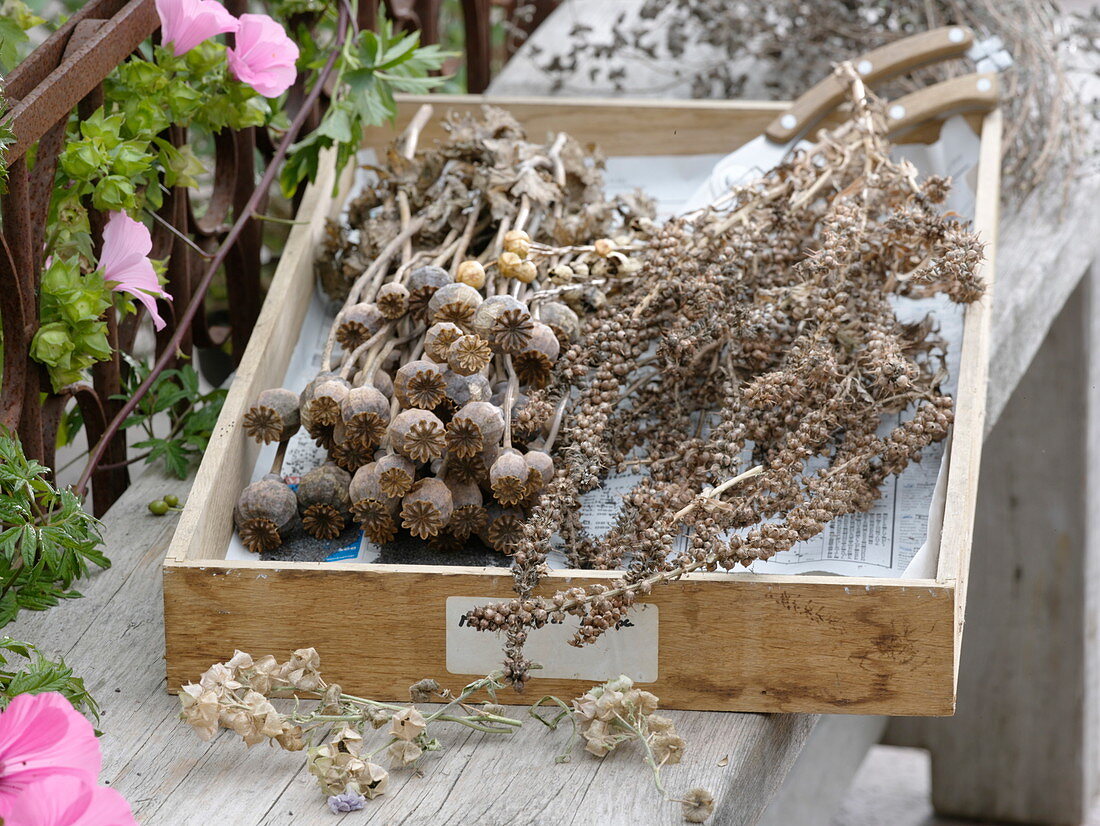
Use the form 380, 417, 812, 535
31, 256, 112, 393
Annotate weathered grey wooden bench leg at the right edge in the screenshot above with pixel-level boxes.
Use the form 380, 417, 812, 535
890, 269, 1100, 824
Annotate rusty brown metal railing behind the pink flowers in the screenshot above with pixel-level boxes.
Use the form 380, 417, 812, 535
0, 0, 528, 515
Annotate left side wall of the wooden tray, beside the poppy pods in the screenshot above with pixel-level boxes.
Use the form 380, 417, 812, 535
168, 152, 351, 560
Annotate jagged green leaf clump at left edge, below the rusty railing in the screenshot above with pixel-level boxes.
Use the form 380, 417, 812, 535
0, 430, 110, 627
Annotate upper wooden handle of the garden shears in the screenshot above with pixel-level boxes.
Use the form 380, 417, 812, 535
763, 25, 974, 143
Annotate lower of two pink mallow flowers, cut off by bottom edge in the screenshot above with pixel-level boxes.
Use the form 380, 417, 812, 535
3, 774, 138, 826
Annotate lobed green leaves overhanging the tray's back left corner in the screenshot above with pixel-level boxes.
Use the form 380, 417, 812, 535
279, 18, 452, 198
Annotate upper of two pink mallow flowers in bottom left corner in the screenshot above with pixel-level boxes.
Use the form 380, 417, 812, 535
0, 692, 102, 819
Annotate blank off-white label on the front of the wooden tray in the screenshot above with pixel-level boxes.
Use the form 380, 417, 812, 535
447, 596, 658, 683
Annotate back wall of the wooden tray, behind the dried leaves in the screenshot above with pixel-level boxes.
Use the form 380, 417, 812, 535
364, 95, 788, 155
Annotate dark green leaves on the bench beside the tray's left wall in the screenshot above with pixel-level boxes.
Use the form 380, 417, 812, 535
120, 360, 226, 478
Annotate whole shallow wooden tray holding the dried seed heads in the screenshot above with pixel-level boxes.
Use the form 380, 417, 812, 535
164, 96, 1001, 715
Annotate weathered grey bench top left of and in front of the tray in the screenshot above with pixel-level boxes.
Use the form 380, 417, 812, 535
4, 471, 816, 826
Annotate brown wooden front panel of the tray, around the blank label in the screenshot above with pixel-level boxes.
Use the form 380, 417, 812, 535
164, 561, 954, 715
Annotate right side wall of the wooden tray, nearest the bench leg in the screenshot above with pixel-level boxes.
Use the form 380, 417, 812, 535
936, 109, 1002, 680
